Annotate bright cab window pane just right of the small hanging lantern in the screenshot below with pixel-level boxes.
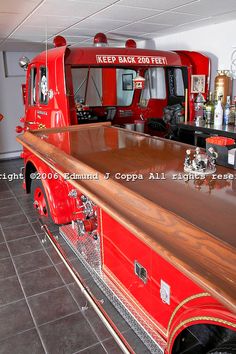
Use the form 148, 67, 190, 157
140, 68, 166, 102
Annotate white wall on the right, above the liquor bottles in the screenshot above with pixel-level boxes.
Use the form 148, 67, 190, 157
141, 19, 236, 95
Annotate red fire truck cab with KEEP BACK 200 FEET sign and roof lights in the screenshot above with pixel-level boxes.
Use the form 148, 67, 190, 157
21, 34, 210, 135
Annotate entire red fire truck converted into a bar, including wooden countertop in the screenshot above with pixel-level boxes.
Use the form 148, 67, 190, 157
17, 34, 236, 354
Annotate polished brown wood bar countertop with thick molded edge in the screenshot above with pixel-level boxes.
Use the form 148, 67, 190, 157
17, 124, 236, 311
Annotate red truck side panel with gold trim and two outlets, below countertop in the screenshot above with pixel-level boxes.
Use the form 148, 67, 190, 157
101, 212, 235, 338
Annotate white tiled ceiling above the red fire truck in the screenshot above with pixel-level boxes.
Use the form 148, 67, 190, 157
0, 0, 236, 51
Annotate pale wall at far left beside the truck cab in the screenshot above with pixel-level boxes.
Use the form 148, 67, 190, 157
0, 52, 35, 160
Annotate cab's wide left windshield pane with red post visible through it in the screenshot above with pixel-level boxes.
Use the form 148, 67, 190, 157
72, 67, 136, 107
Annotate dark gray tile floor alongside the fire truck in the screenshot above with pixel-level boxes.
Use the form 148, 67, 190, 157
0, 160, 149, 354
